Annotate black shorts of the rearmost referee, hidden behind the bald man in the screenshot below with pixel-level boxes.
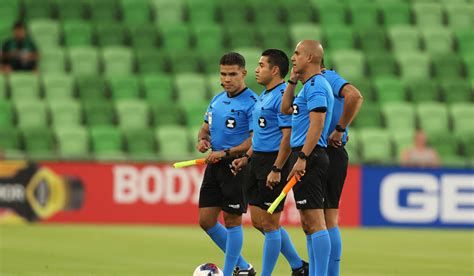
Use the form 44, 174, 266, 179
324, 147, 349, 209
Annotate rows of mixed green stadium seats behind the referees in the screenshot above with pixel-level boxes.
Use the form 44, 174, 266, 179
0, 0, 474, 166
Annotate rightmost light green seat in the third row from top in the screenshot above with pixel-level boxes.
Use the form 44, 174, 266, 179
397, 52, 431, 80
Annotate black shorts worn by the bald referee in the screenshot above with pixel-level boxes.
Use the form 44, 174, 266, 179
289, 146, 329, 210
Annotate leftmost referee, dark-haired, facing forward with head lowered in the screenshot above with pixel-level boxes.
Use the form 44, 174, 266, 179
196, 52, 257, 276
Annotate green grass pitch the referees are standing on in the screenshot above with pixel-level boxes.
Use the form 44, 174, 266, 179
0, 225, 474, 276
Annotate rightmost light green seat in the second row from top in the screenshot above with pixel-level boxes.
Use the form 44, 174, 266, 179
421, 27, 453, 56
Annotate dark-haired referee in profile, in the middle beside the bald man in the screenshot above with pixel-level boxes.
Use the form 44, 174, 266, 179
232, 49, 308, 276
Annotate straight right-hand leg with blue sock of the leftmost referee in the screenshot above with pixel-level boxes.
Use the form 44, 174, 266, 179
224, 212, 243, 276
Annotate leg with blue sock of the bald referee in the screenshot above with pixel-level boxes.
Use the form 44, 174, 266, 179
300, 209, 331, 276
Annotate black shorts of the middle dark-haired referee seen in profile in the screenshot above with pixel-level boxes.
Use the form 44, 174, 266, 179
246, 152, 290, 213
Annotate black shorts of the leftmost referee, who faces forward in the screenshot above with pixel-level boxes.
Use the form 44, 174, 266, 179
199, 158, 248, 214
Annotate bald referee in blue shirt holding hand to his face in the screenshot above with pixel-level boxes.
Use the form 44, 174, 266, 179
281, 40, 334, 276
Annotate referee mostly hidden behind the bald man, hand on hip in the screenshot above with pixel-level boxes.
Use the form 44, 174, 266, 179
321, 62, 363, 276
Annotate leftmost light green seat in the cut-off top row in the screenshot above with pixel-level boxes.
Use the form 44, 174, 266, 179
151, 0, 184, 26
